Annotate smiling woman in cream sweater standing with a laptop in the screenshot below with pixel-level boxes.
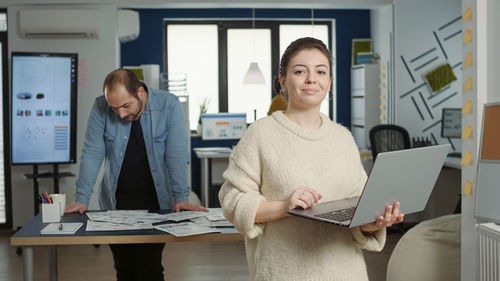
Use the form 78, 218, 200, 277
219, 38, 403, 280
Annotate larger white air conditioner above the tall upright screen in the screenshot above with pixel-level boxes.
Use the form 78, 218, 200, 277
18, 9, 99, 38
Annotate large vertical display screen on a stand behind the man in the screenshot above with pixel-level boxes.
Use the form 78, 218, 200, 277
11, 52, 78, 164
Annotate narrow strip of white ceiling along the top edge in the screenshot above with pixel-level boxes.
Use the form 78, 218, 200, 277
0, 0, 393, 9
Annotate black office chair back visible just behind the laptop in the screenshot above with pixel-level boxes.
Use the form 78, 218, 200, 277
370, 124, 411, 160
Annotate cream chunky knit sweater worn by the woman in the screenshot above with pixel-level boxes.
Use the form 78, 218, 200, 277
219, 111, 385, 281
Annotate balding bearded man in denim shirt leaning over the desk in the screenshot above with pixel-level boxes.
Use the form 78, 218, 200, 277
66, 69, 207, 281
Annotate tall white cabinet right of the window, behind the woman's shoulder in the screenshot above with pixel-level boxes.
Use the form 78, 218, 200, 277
351, 64, 380, 149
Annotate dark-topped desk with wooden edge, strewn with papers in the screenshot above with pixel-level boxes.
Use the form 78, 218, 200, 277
10, 213, 243, 281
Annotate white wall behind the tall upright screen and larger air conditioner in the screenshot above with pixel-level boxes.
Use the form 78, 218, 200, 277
8, 5, 119, 227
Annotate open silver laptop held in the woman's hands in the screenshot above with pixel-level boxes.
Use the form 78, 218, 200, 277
287, 144, 451, 227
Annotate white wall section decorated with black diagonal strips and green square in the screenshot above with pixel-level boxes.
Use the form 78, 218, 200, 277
394, 0, 462, 148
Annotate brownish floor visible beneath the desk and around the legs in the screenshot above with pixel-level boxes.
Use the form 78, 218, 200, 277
0, 232, 401, 281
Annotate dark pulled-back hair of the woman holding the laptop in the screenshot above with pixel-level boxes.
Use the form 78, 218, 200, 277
280, 37, 333, 77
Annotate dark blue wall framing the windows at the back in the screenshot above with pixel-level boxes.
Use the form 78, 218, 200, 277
121, 9, 370, 128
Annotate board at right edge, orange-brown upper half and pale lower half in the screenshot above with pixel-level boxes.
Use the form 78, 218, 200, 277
474, 102, 500, 223
